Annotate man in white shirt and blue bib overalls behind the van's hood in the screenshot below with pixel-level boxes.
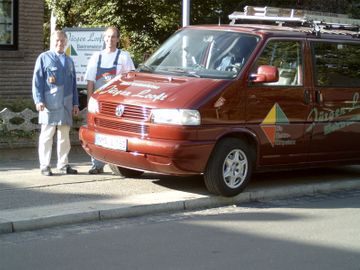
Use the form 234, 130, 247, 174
85, 27, 135, 174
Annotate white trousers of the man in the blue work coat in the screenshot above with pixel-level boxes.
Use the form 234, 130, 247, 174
39, 125, 71, 169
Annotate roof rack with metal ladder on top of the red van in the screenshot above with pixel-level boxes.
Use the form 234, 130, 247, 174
229, 6, 360, 34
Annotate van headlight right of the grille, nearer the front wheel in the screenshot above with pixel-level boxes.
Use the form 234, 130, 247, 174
151, 109, 201, 126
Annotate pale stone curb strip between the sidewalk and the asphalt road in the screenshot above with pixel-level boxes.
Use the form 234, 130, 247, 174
0, 177, 360, 234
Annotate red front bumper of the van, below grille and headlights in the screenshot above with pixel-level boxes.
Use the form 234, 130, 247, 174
79, 126, 215, 175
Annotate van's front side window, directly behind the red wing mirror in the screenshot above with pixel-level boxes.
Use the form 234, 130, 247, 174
252, 40, 303, 86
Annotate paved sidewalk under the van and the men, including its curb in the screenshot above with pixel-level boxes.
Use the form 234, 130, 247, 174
0, 147, 360, 233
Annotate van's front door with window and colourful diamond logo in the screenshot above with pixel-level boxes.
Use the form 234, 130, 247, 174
246, 39, 311, 166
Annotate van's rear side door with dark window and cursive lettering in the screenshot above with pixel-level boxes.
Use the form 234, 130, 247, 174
307, 40, 360, 161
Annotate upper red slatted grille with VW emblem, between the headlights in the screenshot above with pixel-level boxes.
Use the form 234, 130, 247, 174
100, 102, 151, 121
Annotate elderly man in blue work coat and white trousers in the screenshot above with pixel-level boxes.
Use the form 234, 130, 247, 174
32, 30, 79, 176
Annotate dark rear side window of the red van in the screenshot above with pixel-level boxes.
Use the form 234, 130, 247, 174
312, 42, 360, 87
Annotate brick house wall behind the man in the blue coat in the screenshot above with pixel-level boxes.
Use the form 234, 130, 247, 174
0, 0, 44, 100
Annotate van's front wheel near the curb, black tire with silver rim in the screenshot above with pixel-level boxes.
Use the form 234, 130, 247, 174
204, 138, 255, 197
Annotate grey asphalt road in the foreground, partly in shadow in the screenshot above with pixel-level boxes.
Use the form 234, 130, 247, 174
0, 190, 360, 270
